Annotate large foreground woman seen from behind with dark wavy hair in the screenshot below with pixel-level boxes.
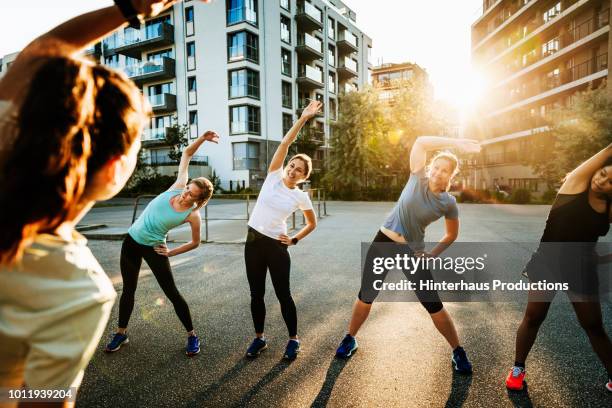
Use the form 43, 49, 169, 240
0, 0, 186, 406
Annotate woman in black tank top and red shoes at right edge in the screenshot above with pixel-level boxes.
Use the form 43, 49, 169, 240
506, 145, 612, 391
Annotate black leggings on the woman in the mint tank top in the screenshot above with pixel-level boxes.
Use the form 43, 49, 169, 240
119, 234, 193, 332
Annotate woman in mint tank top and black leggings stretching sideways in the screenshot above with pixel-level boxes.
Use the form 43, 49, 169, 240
106, 131, 219, 356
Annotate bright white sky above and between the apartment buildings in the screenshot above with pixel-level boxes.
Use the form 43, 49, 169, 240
0, 0, 483, 109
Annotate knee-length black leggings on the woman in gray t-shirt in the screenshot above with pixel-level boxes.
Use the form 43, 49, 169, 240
357, 230, 443, 314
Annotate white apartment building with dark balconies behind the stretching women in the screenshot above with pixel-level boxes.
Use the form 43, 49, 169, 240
76, 0, 372, 190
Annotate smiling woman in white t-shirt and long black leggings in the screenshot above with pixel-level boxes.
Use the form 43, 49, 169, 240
244, 101, 321, 360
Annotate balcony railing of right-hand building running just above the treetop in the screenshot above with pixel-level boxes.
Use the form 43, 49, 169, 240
497, 53, 608, 108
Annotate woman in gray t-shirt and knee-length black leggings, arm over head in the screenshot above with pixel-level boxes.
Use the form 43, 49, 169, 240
336, 136, 480, 373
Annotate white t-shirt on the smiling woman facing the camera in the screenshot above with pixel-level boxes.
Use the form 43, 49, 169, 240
249, 168, 313, 239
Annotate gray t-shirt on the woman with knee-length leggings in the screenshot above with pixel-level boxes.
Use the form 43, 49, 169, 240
383, 168, 459, 249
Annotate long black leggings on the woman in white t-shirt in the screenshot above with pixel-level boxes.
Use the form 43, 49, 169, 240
244, 227, 297, 336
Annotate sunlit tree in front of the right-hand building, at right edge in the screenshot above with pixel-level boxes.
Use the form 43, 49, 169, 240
530, 88, 612, 189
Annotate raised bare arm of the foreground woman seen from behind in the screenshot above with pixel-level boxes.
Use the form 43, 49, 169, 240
0, 0, 184, 100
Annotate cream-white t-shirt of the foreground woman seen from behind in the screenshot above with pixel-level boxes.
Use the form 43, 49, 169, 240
0, 232, 117, 389
